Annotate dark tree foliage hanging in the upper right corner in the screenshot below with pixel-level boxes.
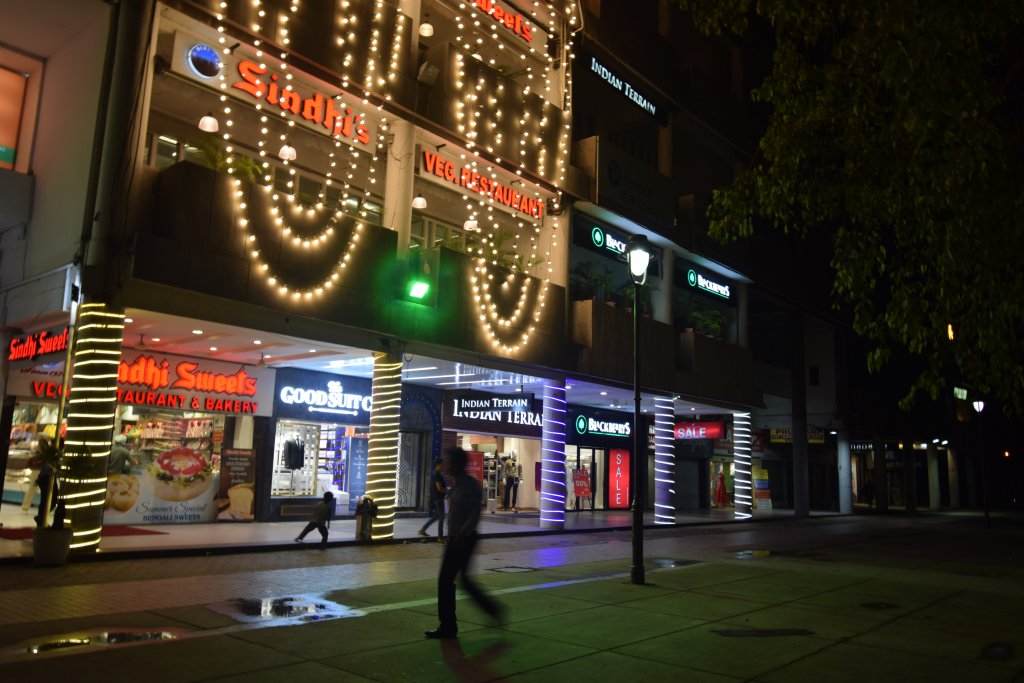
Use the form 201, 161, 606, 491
679, 0, 1024, 414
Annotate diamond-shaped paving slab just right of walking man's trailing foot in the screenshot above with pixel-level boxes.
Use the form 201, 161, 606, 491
505, 605, 702, 650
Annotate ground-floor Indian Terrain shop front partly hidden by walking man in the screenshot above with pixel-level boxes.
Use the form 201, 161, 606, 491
441, 391, 544, 511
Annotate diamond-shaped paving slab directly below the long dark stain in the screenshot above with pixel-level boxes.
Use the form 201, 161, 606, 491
613, 625, 835, 680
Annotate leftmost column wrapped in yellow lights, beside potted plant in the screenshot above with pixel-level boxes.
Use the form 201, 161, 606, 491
57, 303, 125, 552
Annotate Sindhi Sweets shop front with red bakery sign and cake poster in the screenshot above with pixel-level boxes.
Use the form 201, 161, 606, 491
103, 348, 273, 525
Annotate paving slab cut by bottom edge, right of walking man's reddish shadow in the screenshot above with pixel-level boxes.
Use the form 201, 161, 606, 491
504, 652, 740, 683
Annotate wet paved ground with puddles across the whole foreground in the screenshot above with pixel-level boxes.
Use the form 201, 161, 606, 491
0, 517, 1024, 683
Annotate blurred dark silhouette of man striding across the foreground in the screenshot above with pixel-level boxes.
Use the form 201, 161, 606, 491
424, 447, 504, 638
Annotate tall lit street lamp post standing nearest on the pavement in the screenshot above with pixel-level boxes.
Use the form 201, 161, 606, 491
626, 234, 650, 585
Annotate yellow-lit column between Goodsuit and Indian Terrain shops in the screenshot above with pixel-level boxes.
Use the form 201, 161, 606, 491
367, 353, 401, 541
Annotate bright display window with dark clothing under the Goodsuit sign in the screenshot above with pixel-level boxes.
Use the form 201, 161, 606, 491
270, 420, 370, 513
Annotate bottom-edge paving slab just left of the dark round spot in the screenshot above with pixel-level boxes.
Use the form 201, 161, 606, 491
754, 643, 1010, 683
